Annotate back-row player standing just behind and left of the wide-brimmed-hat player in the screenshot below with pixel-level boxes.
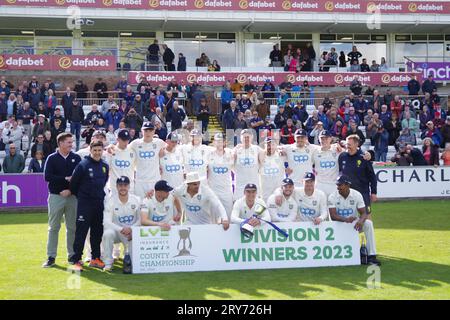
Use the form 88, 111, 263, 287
159, 132, 184, 187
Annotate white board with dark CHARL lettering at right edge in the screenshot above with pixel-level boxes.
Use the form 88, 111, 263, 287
374, 167, 450, 199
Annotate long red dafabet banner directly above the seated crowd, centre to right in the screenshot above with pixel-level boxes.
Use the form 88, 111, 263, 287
128, 71, 421, 86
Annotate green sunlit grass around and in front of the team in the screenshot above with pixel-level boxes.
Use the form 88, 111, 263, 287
0, 200, 450, 299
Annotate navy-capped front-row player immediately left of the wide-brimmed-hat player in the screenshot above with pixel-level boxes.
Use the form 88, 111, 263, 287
141, 180, 181, 230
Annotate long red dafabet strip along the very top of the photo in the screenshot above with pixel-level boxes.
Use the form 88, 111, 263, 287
0, 0, 450, 14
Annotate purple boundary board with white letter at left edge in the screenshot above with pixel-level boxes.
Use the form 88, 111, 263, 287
0, 174, 48, 208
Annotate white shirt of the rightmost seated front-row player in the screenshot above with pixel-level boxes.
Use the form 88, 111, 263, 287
328, 189, 366, 218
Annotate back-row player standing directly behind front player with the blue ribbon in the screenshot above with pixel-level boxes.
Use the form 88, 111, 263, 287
233, 129, 264, 200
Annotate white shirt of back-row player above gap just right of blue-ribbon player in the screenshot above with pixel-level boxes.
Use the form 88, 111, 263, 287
259, 152, 286, 200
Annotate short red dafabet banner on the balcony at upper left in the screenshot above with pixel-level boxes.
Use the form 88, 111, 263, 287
0, 54, 116, 71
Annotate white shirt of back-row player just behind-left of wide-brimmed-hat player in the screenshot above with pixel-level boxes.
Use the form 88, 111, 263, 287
159, 147, 184, 188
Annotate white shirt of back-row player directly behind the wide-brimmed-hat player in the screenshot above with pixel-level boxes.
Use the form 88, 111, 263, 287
180, 144, 212, 178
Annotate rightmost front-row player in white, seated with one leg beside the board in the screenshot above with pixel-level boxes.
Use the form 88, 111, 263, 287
328, 175, 381, 265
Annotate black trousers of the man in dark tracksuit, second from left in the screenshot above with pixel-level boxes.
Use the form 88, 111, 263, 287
70, 198, 104, 262
